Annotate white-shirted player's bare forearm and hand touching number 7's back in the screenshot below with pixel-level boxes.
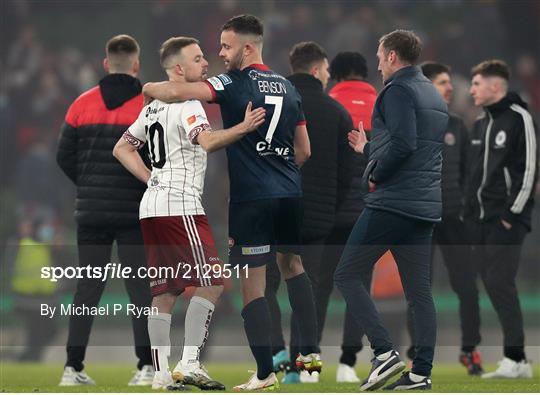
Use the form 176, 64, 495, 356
196, 102, 266, 153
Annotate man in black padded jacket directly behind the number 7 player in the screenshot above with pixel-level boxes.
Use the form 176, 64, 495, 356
266, 42, 365, 382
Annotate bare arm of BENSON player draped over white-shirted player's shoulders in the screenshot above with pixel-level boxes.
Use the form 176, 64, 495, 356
143, 81, 214, 103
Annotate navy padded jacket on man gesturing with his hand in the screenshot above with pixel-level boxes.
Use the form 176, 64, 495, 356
364, 66, 448, 222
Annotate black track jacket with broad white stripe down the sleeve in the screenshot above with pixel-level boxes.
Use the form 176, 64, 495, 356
465, 92, 538, 229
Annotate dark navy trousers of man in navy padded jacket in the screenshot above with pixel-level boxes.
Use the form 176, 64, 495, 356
334, 208, 437, 376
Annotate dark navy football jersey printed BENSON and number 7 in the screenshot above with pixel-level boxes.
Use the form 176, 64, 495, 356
206, 65, 305, 203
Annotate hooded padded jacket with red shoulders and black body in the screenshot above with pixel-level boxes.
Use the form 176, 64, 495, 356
56, 74, 149, 227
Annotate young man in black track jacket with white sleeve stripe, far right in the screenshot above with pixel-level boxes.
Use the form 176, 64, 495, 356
465, 60, 538, 379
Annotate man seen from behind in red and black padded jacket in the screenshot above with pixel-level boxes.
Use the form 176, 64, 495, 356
56, 35, 153, 385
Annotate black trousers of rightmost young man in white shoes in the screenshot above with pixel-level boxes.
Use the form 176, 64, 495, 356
466, 219, 527, 361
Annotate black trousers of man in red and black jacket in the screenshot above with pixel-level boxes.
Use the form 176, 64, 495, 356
66, 226, 152, 371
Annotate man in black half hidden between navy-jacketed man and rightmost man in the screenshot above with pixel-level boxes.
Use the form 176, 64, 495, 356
407, 62, 483, 375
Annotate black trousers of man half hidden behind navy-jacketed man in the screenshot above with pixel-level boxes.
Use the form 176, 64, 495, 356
407, 217, 481, 359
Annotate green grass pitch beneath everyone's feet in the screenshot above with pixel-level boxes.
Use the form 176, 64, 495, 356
0, 362, 540, 393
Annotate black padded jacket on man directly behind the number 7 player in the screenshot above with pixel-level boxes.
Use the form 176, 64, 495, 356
288, 73, 361, 242
